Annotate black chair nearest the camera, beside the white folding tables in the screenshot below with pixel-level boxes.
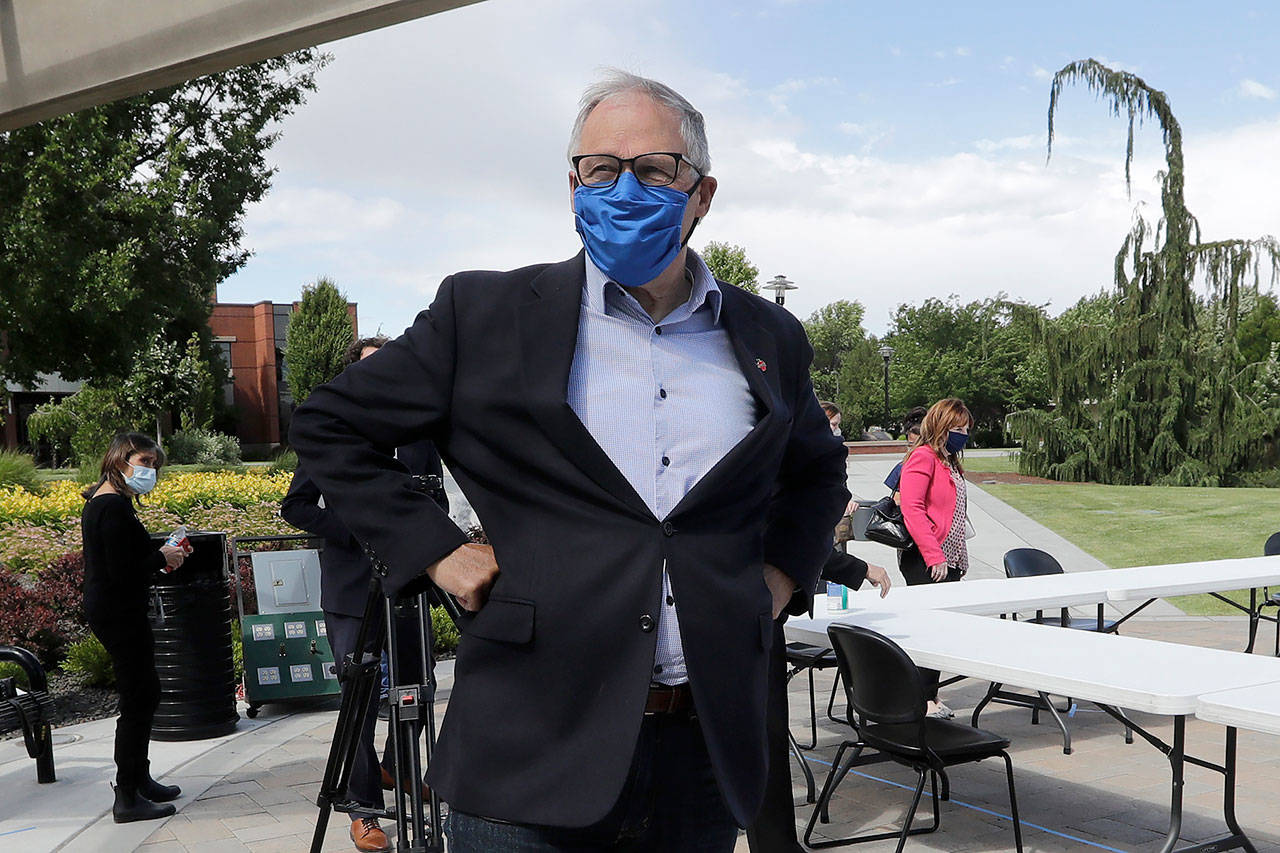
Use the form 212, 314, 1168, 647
804, 625, 1023, 853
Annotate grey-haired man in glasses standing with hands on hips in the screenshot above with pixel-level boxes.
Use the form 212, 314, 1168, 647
291, 72, 849, 853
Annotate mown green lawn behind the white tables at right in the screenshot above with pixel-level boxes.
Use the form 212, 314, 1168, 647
968, 479, 1280, 613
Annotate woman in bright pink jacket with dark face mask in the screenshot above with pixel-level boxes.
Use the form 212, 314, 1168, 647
897, 397, 973, 717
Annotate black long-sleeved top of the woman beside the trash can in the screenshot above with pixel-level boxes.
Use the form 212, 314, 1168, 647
81, 492, 165, 619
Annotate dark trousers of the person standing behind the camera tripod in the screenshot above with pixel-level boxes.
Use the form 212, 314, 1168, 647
324, 601, 422, 808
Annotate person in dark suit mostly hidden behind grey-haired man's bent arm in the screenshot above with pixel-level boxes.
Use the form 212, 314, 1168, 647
280, 336, 449, 850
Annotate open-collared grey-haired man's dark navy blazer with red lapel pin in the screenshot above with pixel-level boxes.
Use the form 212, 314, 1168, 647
291, 254, 849, 826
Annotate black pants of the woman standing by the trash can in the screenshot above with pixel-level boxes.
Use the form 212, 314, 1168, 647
88, 612, 160, 789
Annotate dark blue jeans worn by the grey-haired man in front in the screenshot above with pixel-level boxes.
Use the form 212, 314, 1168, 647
447, 715, 737, 853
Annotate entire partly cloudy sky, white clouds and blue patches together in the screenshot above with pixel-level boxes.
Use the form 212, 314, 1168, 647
219, 0, 1280, 334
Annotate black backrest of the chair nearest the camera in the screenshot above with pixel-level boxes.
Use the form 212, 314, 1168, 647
827, 625, 925, 731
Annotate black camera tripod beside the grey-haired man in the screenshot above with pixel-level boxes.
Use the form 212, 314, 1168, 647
311, 571, 460, 853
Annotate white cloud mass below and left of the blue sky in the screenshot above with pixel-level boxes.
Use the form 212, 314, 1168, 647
220, 0, 1280, 332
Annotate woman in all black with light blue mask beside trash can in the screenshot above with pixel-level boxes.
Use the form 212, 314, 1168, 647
81, 433, 186, 824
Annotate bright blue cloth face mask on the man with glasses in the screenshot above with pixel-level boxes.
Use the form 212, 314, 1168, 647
573, 172, 692, 287
